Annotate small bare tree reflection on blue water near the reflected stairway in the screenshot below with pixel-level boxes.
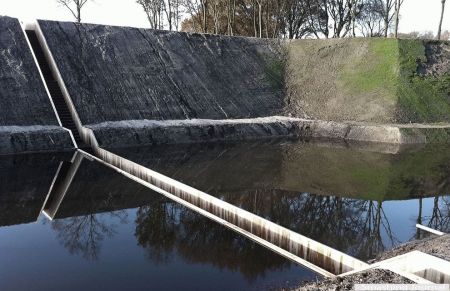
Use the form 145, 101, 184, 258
51, 210, 127, 260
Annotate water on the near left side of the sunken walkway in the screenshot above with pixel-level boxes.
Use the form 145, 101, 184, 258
0, 155, 317, 290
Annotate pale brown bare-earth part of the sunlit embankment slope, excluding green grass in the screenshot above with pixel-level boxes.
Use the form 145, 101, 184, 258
285, 39, 396, 123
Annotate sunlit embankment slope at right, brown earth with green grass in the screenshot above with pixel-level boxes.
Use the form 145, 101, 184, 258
286, 38, 450, 123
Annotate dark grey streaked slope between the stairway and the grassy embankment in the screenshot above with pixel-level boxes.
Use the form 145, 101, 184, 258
39, 20, 283, 124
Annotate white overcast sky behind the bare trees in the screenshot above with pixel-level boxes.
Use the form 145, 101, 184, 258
0, 0, 450, 34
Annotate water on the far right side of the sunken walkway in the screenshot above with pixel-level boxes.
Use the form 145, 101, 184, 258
113, 141, 450, 260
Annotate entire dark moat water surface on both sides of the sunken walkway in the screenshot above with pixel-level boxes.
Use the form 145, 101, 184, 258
0, 141, 450, 290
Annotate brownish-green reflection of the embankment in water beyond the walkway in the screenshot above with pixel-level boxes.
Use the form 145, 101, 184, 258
113, 142, 450, 201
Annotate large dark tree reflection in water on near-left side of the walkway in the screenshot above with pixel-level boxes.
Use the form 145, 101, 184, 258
135, 198, 290, 281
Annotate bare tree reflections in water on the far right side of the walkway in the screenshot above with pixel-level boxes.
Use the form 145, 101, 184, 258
220, 190, 398, 260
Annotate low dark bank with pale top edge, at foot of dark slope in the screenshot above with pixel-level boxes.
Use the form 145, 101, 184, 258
88, 117, 311, 147
